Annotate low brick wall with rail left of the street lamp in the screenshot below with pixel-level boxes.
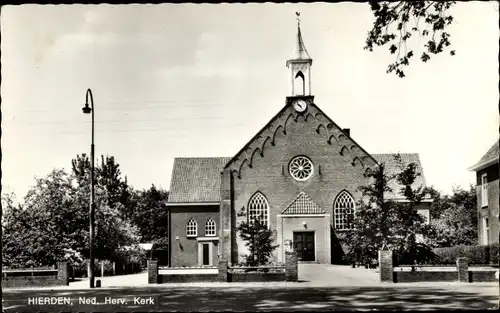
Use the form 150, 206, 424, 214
2, 262, 69, 288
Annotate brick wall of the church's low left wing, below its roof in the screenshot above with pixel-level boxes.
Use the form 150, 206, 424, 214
169, 206, 220, 267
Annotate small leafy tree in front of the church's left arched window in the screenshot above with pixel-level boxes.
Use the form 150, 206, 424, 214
238, 218, 278, 266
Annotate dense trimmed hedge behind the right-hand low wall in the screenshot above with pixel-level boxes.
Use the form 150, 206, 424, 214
429, 244, 498, 264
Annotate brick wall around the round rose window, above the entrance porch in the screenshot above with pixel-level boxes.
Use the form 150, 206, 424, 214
225, 103, 372, 262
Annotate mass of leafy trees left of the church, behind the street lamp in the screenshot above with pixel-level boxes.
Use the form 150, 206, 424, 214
2, 154, 168, 267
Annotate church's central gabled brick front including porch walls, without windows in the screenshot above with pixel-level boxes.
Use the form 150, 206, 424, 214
224, 98, 374, 263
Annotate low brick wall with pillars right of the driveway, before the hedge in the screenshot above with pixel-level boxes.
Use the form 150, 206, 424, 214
379, 250, 498, 283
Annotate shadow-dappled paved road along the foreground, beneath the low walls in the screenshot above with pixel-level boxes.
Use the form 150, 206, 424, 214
2, 282, 498, 312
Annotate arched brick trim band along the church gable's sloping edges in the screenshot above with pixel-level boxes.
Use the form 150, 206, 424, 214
225, 96, 377, 179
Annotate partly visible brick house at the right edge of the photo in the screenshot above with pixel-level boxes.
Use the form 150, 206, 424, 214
469, 141, 500, 245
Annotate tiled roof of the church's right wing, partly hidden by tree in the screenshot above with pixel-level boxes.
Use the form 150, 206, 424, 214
372, 153, 426, 199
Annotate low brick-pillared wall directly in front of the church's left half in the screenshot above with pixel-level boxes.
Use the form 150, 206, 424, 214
148, 253, 298, 284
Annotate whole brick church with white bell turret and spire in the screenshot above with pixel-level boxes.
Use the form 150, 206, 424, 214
167, 18, 431, 266
